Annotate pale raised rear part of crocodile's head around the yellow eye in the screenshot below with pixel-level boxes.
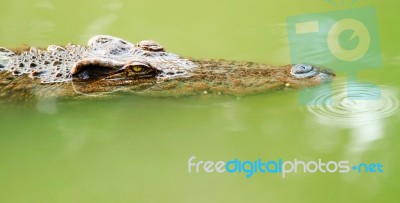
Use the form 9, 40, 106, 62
71, 35, 196, 93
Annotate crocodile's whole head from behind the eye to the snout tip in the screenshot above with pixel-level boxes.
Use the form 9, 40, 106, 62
71, 35, 334, 96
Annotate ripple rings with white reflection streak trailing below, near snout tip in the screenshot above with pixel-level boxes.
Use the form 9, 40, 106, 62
307, 80, 399, 167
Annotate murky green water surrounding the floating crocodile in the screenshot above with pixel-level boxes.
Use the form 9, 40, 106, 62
0, 0, 400, 203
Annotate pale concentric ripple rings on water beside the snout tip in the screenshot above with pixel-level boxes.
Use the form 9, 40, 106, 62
307, 81, 399, 127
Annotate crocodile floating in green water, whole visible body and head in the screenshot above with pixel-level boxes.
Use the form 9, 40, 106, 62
0, 35, 335, 101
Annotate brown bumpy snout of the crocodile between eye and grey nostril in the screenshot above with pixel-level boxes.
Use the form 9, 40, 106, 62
140, 59, 321, 96
